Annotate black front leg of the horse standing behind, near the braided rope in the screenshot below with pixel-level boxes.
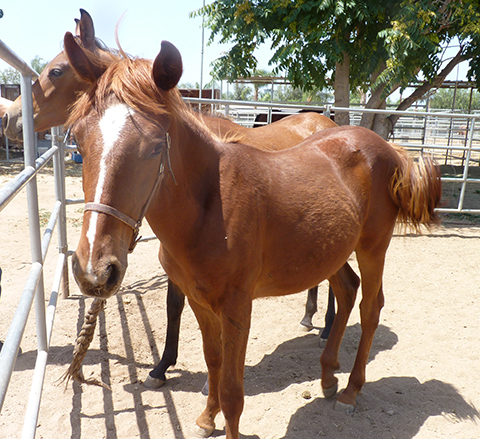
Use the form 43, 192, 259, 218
144, 279, 185, 389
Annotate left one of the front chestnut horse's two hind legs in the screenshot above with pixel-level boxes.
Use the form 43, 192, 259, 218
320, 263, 360, 398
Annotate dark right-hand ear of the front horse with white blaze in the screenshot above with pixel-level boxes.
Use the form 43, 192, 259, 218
152, 41, 183, 91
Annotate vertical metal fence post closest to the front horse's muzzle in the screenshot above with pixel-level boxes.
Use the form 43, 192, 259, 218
52, 127, 70, 299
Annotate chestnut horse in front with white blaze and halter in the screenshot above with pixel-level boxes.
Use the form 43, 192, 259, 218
65, 34, 441, 439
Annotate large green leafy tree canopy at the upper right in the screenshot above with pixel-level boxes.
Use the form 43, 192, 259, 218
193, 0, 480, 137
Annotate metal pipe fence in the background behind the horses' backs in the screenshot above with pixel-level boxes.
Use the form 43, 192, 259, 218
184, 98, 480, 214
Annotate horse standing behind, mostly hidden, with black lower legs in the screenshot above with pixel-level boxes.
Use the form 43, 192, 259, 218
3, 9, 337, 388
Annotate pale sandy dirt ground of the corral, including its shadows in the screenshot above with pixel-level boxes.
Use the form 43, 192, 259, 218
0, 166, 480, 439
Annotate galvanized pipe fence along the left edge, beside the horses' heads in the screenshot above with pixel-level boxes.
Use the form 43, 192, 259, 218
0, 40, 68, 439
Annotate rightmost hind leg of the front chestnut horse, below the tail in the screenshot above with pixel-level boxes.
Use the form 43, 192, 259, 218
337, 249, 385, 412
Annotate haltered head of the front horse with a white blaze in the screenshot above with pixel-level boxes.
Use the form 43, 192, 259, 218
65, 33, 182, 298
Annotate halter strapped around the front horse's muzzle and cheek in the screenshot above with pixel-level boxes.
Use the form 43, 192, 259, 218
84, 133, 177, 253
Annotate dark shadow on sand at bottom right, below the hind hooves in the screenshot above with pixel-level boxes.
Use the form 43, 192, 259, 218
276, 377, 480, 439
